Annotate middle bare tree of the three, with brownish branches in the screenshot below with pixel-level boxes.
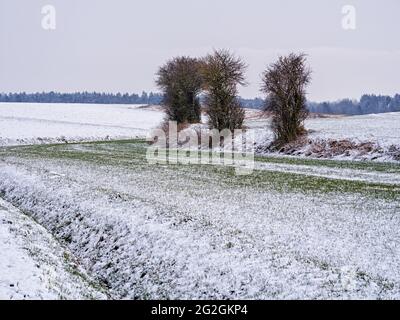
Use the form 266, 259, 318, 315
202, 50, 247, 130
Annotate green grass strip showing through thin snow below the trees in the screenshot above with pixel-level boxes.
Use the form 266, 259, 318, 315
0, 140, 400, 200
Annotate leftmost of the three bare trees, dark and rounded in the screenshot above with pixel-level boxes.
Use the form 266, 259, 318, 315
156, 57, 203, 124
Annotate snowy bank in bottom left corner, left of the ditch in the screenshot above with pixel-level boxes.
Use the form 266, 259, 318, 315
0, 198, 106, 300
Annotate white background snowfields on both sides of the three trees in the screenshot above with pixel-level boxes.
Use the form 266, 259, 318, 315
0, 103, 400, 152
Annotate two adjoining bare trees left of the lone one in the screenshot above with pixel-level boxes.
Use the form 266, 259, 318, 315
156, 50, 246, 130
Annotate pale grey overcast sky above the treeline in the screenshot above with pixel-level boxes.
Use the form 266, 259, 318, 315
0, 0, 400, 101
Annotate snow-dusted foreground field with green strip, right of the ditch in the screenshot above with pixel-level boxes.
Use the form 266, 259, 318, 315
0, 143, 400, 299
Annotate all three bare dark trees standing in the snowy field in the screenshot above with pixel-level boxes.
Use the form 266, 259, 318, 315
156, 50, 311, 147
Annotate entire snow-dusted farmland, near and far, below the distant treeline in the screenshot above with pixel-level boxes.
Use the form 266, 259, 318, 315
0, 105, 400, 299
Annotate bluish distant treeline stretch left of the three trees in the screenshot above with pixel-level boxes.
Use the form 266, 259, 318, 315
0, 91, 162, 104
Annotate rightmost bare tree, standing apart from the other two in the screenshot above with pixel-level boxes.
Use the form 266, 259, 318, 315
261, 53, 311, 147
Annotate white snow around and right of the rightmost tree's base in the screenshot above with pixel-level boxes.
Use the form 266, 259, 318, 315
246, 112, 400, 162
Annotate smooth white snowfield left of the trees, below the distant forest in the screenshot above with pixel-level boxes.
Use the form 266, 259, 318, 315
0, 103, 163, 146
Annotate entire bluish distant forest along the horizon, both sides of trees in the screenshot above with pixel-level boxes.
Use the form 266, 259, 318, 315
0, 91, 400, 115
